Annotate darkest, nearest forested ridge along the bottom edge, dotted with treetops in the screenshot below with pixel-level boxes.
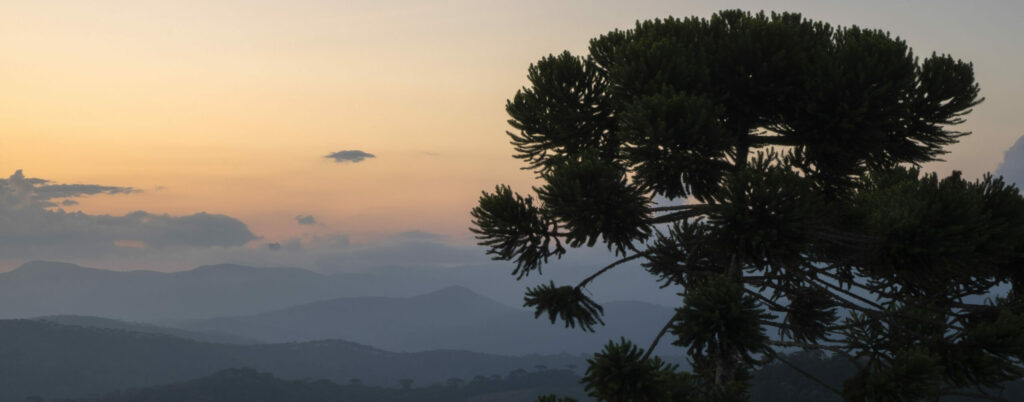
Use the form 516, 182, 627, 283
54, 353, 1024, 402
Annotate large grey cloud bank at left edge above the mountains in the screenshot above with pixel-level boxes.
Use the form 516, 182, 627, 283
0, 171, 258, 259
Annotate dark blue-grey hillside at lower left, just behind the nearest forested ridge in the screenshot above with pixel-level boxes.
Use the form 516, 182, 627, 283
0, 320, 585, 402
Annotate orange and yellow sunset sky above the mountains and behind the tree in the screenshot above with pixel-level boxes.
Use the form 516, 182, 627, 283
0, 0, 1024, 271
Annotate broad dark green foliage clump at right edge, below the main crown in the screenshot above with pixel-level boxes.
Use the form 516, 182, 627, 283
853, 169, 1024, 293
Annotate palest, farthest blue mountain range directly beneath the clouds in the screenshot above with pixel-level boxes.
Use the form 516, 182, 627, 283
0, 261, 676, 323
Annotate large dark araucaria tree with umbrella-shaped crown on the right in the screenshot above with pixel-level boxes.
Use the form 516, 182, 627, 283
472, 11, 1024, 401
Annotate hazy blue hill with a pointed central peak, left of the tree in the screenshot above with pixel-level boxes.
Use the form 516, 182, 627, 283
182, 286, 674, 355
